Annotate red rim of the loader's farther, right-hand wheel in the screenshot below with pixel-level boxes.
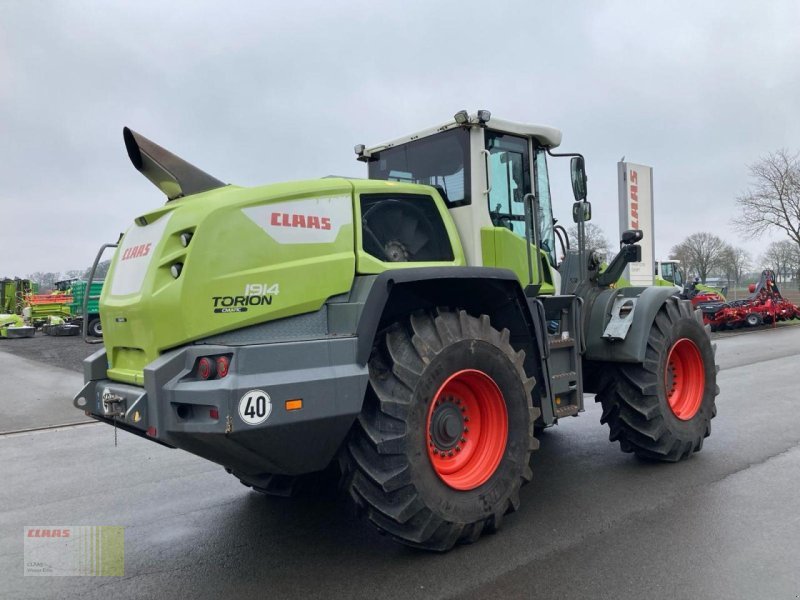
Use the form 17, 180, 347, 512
664, 338, 706, 421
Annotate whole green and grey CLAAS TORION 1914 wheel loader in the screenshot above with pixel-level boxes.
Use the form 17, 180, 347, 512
75, 111, 718, 550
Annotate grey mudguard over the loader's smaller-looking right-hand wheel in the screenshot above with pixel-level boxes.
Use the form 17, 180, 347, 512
584, 287, 675, 363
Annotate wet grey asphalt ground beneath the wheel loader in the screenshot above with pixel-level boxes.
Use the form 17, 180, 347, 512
0, 327, 800, 599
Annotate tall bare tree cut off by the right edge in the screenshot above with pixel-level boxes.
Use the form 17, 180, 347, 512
733, 149, 800, 258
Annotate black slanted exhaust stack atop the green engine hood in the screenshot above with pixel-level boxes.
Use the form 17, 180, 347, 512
122, 127, 226, 200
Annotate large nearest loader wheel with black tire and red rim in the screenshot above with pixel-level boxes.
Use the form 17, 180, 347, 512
343, 309, 540, 551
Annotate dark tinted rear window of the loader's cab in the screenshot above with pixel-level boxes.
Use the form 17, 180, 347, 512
369, 128, 471, 208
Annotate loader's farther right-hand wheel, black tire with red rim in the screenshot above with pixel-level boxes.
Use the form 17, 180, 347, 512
596, 298, 719, 462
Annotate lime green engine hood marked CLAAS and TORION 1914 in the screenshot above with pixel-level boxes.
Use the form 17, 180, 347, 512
100, 179, 355, 385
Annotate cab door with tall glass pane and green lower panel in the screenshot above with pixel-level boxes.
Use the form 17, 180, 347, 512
481, 130, 552, 293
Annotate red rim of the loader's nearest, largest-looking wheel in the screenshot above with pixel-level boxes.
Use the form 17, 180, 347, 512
426, 369, 508, 490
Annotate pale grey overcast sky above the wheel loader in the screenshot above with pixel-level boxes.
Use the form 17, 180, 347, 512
0, 0, 800, 276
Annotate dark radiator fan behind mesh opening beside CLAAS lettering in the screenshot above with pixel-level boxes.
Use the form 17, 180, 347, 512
361, 200, 435, 262
